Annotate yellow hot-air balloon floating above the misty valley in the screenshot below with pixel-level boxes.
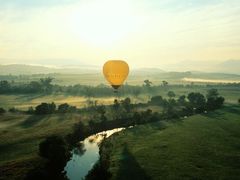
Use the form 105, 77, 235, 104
103, 60, 129, 89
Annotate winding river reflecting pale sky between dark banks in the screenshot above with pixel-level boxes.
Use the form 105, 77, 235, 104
64, 128, 125, 180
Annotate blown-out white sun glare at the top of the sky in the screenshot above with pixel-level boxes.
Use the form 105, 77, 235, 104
68, 1, 138, 46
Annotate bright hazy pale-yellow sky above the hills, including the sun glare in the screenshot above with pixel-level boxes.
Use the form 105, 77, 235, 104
0, 0, 240, 67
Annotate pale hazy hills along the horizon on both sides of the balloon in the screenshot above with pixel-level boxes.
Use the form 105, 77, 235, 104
0, 63, 240, 79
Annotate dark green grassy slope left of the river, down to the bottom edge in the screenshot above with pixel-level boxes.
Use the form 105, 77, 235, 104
0, 113, 84, 179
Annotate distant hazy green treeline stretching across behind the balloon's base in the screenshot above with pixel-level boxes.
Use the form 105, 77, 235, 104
0, 77, 240, 97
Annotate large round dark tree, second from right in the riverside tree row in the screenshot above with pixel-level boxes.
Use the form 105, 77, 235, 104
187, 92, 206, 113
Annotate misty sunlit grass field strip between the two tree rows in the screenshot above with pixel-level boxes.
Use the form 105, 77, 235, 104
0, 86, 240, 110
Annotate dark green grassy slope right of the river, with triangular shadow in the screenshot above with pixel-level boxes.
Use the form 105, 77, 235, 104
109, 106, 240, 179
